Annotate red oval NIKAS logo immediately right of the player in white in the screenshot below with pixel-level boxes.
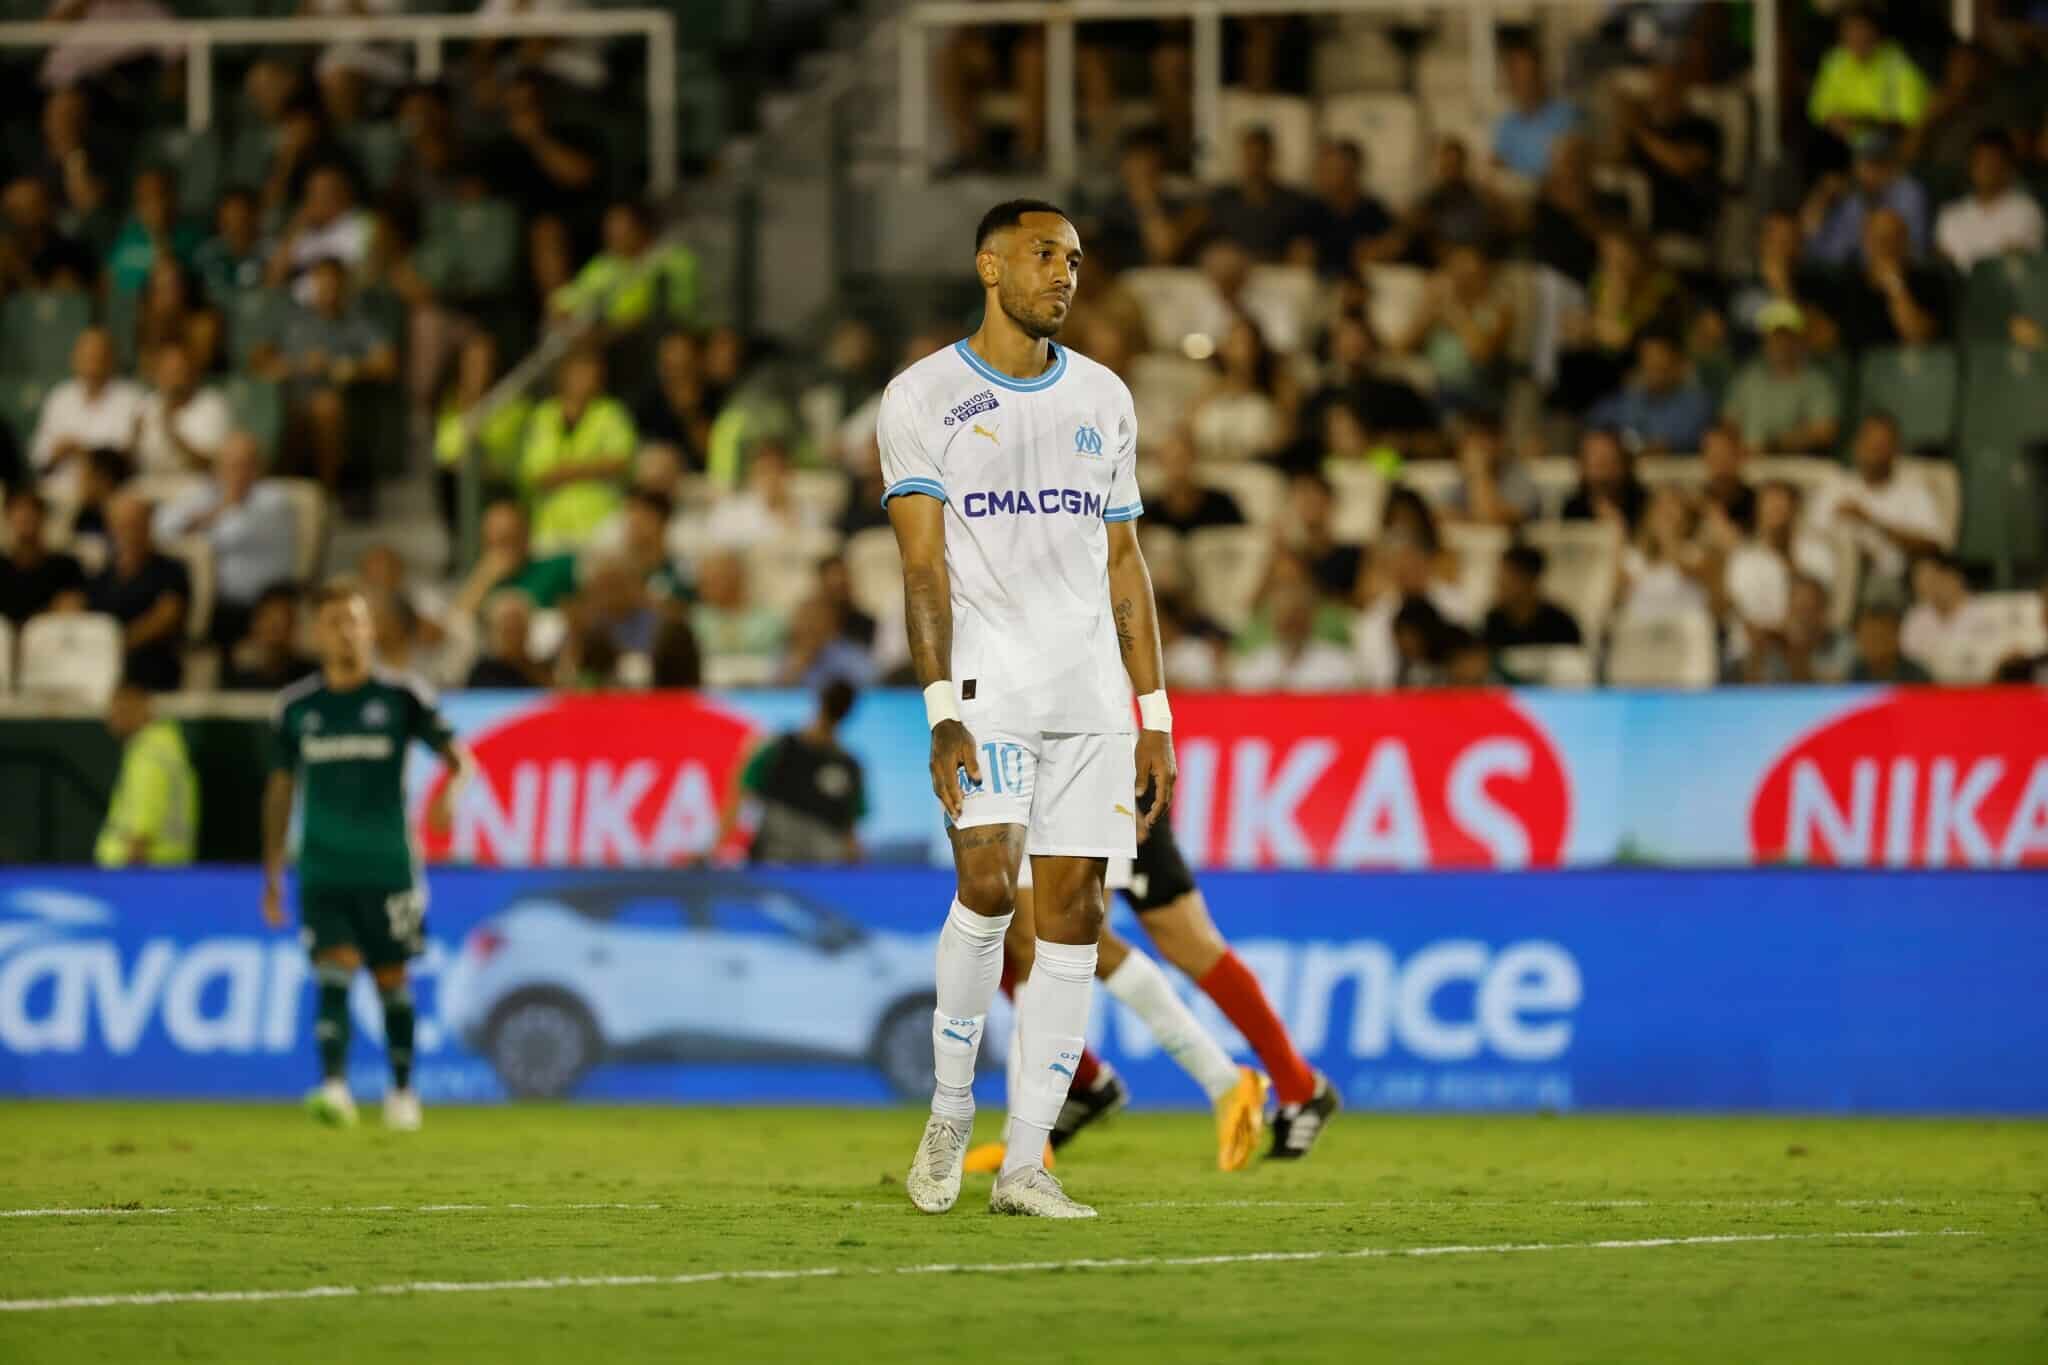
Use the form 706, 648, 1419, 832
1174, 692, 1573, 868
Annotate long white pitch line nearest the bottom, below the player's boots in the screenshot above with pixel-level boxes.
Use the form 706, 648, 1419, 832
0, 1228, 1978, 1314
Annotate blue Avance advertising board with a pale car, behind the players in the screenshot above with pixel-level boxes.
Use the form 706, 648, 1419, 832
0, 868, 2048, 1113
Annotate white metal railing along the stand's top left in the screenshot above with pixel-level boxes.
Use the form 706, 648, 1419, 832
0, 10, 680, 194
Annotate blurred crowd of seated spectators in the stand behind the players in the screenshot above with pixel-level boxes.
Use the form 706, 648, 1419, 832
0, 0, 2048, 692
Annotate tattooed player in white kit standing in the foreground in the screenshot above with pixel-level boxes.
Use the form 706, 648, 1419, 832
881, 199, 1176, 1218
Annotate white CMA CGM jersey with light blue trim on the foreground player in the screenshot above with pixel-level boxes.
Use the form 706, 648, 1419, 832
881, 342, 1145, 733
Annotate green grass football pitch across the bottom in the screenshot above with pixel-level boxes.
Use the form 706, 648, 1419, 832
0, 1103, 2048, 1365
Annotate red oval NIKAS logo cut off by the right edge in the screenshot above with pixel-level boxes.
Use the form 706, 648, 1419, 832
1749, 688, 2048, 868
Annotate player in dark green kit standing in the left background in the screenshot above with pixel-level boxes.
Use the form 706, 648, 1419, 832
262, 579, 473, 1132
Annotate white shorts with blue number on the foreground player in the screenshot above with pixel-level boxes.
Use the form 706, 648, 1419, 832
954, 722, 1139, 866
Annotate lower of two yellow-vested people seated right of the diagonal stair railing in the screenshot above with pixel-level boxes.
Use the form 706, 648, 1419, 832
518, 350, 639, 553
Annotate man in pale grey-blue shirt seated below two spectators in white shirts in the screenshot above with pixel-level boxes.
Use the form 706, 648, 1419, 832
154, 432, 299, 645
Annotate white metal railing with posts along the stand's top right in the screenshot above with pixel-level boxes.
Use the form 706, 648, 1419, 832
897, 0, 1777, 180
